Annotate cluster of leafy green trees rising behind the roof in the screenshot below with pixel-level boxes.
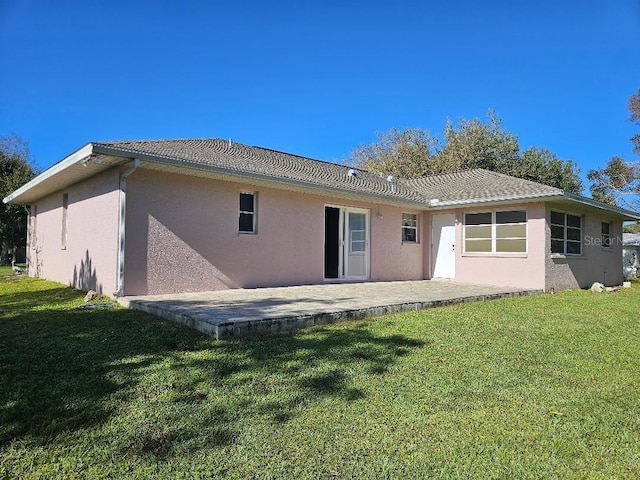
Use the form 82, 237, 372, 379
345, 111, 584, 193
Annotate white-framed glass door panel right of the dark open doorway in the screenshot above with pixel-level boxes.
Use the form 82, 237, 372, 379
343, 209, 369, 280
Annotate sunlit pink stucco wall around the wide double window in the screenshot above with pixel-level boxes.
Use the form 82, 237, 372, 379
442, 203, 545, 289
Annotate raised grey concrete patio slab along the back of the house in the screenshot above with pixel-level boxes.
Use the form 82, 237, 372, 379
118, 280, 542, 339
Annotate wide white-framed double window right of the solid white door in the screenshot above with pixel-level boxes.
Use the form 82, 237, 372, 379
464, 210, 527, 254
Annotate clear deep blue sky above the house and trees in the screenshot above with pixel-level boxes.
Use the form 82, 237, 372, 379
0, 0, 640, 193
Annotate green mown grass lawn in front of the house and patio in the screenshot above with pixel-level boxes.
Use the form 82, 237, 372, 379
0, 270, 640, 479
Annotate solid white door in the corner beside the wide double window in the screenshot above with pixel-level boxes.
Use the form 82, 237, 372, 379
431, 213, 456, 278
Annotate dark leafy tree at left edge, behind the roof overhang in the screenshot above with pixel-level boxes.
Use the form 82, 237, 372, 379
0, 134, 35, 260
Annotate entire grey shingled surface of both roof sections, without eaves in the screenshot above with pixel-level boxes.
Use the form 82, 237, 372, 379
94, 139, 563, 204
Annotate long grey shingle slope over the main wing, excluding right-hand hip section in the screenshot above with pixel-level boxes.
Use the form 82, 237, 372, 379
93, 139, 425, 203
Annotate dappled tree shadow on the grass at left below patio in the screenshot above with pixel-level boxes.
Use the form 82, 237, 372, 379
0, 280, 424, 457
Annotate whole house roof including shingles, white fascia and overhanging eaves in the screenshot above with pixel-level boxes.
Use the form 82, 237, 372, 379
4, 139, 640, 220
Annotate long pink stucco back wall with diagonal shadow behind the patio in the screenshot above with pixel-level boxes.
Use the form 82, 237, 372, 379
125, 169, 423, 295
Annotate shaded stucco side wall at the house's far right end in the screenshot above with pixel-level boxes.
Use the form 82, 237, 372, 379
545, 207, 623, 291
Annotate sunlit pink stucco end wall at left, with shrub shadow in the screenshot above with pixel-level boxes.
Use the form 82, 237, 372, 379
28, 169, 119, 295
